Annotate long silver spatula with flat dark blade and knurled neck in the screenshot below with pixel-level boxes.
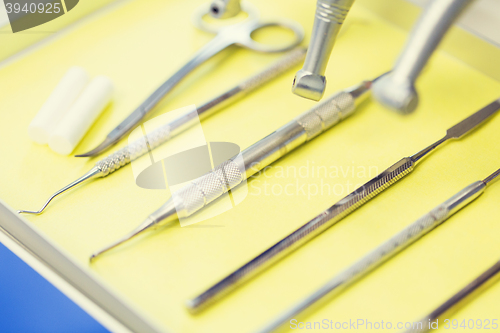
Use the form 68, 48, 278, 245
186, 100, 500, 312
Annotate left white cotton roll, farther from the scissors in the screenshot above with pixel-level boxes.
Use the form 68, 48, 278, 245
28, 67, 90, 144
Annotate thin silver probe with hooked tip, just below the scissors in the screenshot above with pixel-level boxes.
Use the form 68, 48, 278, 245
18, 47, 306, 214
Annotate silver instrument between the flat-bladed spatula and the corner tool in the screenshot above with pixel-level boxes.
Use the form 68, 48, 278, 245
259, 170, 500, 333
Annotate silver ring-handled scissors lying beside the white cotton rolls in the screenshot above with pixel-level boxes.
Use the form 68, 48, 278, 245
76, 4, 304, 157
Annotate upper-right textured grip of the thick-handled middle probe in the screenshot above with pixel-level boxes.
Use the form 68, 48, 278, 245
295, 91, 356, 141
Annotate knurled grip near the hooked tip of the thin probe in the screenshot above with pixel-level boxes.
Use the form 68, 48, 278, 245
96, 120, 171, 177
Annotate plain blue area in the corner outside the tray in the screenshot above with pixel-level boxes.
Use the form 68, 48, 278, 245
0, 243, 108, 333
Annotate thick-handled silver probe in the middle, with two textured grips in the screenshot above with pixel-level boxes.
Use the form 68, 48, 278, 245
90, 75, 373, 260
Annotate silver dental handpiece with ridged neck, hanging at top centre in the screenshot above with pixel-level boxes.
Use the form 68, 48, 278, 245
292, 0, 354, 101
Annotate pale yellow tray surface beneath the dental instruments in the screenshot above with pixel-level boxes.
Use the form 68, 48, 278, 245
0, 0, 500, 332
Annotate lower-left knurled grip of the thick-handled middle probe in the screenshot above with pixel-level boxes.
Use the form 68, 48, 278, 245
172, 160, 245, 218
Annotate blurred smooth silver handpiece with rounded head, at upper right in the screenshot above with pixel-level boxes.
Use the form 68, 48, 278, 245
374, 0, 473, 113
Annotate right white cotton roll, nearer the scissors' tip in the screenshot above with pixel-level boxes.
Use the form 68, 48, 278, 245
49, 76, 113, 155
